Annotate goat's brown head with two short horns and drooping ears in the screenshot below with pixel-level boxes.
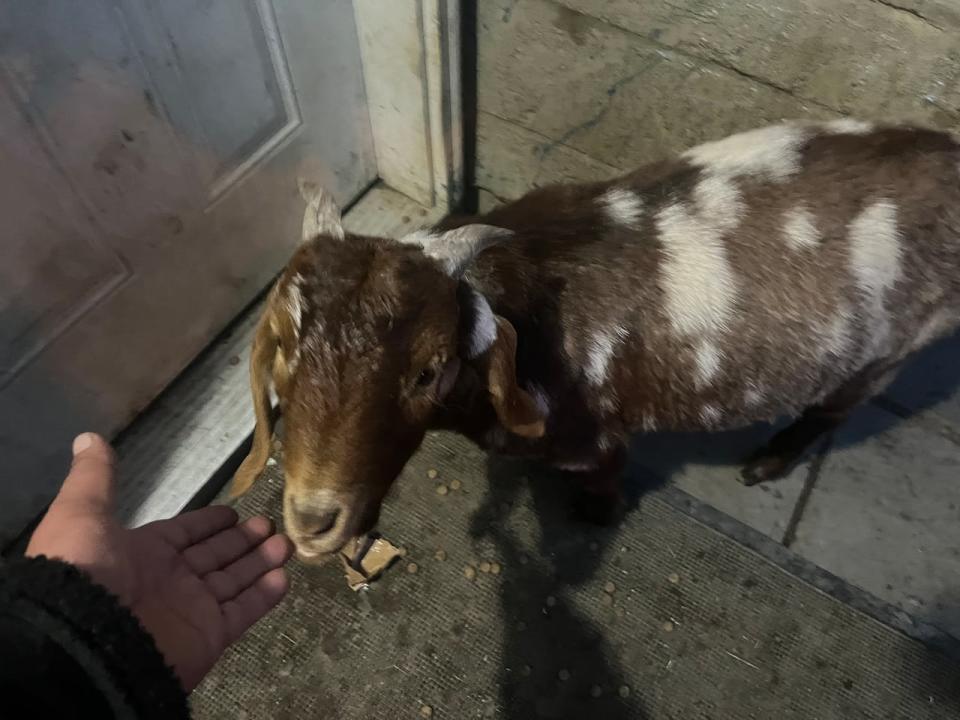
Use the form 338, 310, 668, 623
233, 184, 543, 558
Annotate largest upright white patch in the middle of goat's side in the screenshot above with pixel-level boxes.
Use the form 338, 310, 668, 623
657, 203, 737, 336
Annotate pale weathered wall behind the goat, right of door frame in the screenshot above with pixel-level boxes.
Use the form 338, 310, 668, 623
477, 0, 960, 207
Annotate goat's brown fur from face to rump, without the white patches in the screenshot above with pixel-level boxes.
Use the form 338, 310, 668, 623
236, 121, 960, 548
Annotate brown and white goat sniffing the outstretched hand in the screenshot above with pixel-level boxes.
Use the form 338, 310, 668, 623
234, 120, 960, 556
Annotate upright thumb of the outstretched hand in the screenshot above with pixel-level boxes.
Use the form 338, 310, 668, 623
51, 433, 116, 514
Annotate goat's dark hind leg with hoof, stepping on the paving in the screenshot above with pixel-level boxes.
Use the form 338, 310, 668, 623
740, 363, 899, 486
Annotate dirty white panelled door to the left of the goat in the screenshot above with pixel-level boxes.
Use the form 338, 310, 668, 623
0, 0, 376, 544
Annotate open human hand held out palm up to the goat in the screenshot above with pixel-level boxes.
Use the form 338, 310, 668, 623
27, 433, 293, 691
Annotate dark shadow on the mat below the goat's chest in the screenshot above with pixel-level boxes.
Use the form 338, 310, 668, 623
470, 457, 647, 720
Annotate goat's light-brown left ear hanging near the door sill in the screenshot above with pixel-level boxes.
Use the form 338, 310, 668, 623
229, 280, 303, 497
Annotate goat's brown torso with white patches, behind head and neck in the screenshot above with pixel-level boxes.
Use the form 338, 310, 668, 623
470, 121, 960, 429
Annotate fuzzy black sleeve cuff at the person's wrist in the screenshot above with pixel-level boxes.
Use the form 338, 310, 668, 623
0, 556, 189, 719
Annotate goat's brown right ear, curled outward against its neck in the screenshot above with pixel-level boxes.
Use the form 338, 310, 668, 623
482, 316, 546, 439
